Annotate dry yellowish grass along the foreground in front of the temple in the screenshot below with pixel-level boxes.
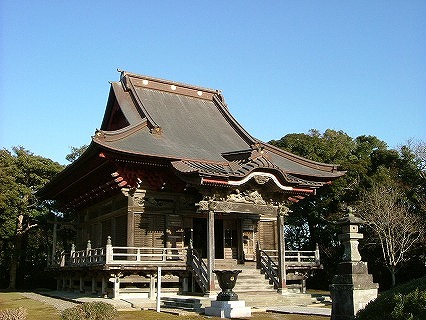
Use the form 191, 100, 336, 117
0, 292, 328, 320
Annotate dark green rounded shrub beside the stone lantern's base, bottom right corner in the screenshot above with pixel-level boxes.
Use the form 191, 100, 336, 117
355, 277, 426, 320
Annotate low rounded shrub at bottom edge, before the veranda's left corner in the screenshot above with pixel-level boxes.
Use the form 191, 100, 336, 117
61, 302, 118, 320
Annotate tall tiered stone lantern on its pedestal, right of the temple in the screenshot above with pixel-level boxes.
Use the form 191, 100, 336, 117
330, 213, 379, 320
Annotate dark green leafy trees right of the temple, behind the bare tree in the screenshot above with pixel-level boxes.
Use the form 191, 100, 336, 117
270, 129, 426, 287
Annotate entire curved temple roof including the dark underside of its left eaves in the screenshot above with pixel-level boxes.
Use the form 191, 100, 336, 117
39, 72, 344, 209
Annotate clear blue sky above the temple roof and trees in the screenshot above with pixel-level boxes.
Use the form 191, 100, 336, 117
0, 0, 426, 163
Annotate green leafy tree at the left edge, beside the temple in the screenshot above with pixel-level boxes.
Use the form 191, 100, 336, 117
0, 147, 63, 288
